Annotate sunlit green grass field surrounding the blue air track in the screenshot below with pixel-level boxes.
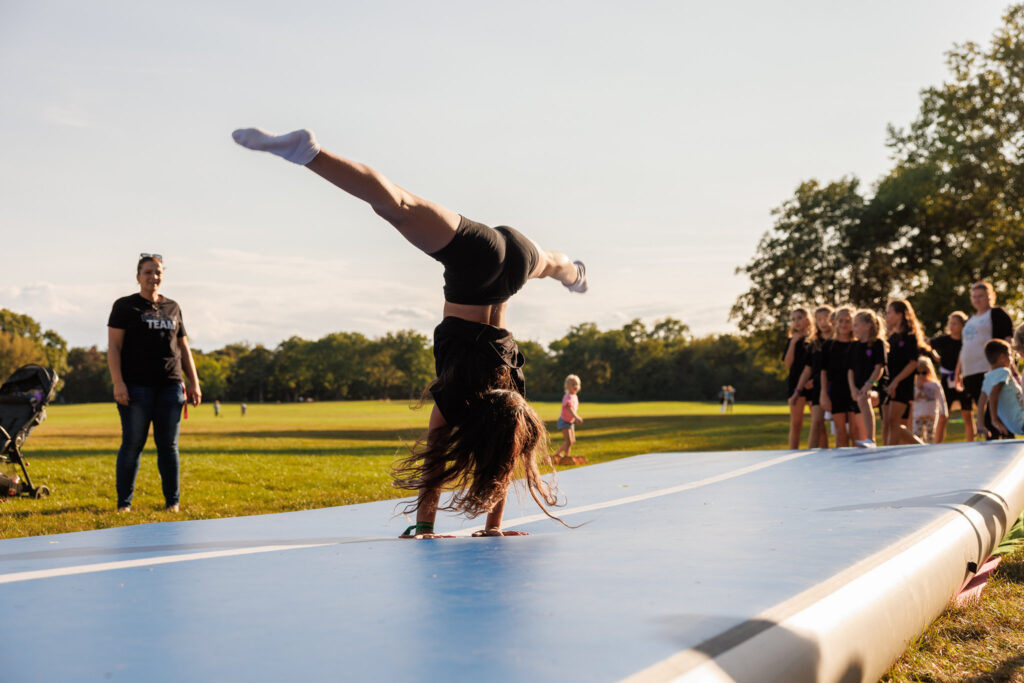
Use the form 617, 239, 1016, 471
0, 401, 1024, 683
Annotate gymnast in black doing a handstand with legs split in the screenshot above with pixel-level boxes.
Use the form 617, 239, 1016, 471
232, 128, 587, 539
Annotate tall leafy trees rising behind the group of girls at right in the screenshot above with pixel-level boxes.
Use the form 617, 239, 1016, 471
732, 5, 1024, 353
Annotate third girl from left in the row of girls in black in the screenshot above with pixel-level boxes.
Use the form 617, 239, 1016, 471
819, 306, 864, 447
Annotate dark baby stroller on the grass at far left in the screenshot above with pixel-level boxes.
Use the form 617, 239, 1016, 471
0, 365, 57, 498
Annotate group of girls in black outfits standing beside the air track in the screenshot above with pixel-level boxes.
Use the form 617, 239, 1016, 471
783, 288, 1009, 449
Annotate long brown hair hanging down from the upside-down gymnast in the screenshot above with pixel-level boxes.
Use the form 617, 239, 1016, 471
394, 367, 564, 524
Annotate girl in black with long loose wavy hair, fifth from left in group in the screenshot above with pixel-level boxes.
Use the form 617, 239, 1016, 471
884, 299, 932, 445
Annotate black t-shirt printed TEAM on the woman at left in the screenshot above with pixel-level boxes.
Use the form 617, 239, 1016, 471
106, 294, 185, 386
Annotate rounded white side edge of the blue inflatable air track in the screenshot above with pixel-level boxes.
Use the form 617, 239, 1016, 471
627, 446, 1024, 683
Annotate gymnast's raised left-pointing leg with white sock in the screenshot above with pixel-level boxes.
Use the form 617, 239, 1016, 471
231, 128, 460, 254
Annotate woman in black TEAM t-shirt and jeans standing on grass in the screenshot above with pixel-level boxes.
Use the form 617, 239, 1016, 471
106, 254, 203, 512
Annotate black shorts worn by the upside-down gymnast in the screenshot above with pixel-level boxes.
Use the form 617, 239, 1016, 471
431, 216, 541, 306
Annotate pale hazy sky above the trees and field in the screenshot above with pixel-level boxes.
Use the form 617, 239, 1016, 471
0, 0, 1008, 351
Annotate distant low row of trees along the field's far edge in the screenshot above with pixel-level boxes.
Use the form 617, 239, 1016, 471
0, 309, 781, 402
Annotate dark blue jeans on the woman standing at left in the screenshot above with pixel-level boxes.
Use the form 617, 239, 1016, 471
118, 384, 185, 508
